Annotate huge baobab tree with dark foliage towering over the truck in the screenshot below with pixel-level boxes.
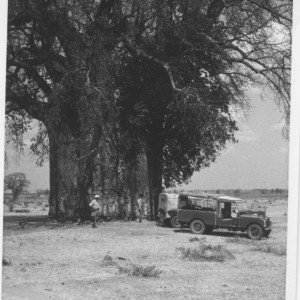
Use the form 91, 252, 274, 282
6, 0, 292, 218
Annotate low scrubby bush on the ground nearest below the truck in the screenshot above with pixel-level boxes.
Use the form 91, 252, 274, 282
177, 238, 235, 262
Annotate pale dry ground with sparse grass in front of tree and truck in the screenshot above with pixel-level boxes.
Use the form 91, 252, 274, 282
2, 199, 287, 300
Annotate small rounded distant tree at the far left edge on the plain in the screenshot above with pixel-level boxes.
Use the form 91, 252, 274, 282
4, 173, 30, 211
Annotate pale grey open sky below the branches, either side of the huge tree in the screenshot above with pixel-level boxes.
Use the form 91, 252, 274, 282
5, 85, 288, 191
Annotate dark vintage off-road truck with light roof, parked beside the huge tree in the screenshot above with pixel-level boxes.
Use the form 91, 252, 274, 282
177, 194, 272, 240
